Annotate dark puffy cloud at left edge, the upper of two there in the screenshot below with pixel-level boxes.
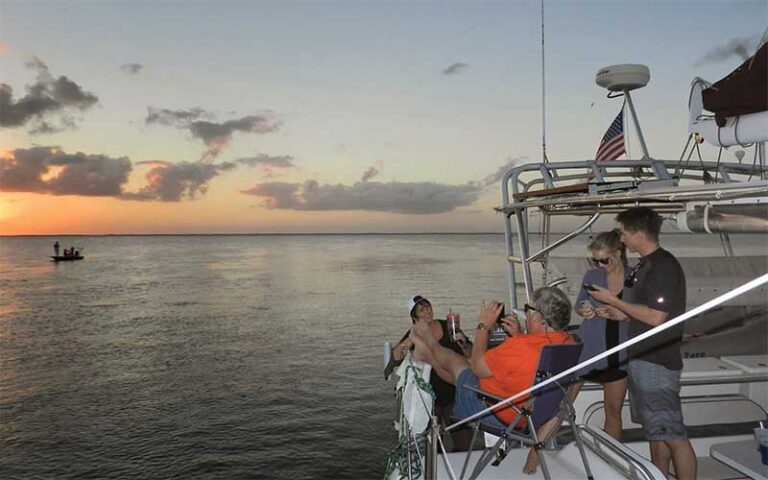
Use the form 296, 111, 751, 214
0, 57, 99, 133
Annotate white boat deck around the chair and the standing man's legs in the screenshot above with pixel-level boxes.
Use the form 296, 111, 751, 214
435, 354, 768, 480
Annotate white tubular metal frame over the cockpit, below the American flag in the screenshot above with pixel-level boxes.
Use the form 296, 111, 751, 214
496, 159, 768, 308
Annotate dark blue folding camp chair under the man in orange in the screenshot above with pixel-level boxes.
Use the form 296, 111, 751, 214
461, 343, 593, 480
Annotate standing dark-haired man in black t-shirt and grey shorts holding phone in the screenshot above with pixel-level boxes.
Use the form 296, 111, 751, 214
589, 207, 696, 479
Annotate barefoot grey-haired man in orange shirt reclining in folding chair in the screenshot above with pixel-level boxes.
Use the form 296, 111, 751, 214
411, 287, 573, 436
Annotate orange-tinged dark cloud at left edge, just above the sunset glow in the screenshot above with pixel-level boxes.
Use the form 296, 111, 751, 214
0, 147, 132, 196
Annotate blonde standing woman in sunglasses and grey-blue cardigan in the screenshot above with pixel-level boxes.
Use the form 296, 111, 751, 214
573, 229, 628, 441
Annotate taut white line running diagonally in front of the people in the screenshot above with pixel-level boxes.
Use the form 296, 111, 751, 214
446, 273, 768, 431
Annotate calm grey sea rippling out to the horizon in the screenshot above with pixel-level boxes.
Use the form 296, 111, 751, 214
0, 235, 765, 479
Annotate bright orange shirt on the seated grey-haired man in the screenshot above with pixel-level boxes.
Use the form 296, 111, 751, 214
480, 331, 573, 423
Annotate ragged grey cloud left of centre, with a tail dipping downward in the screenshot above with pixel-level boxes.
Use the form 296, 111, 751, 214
145, 107, 281, 161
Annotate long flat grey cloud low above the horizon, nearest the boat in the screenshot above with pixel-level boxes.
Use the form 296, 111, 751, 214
242, 180, 482, 214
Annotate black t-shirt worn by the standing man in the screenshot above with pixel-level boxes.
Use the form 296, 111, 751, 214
624, 248, 685, 370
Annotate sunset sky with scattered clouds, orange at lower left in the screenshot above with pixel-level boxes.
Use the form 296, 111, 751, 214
0, 0, 768, 235
